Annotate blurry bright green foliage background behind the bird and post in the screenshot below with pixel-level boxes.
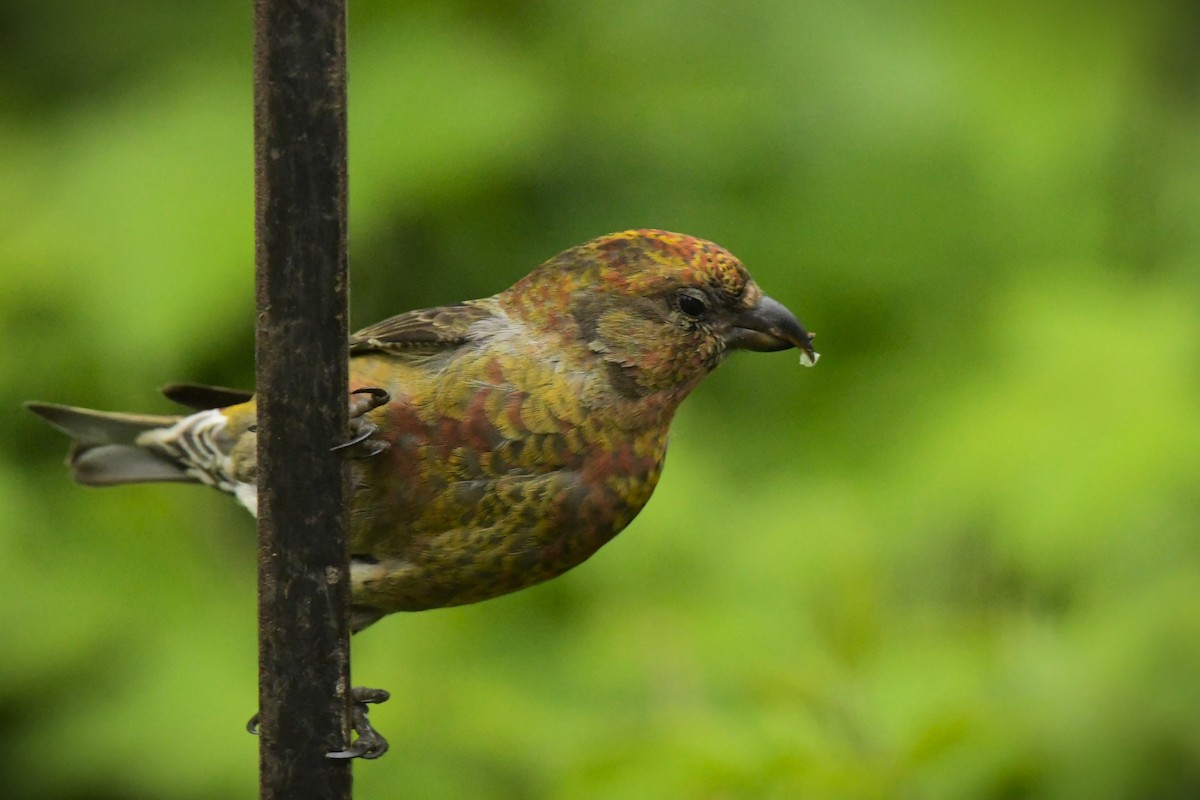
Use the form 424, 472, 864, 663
0, 0, 1200, 800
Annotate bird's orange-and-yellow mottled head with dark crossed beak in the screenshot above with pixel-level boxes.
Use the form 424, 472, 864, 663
505, 230, 817, 398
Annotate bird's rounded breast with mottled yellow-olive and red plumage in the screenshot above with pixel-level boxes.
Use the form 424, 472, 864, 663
352, 352, 666, 610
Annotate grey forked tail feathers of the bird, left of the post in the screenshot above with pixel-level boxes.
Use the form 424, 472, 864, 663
25, 403, 196, 486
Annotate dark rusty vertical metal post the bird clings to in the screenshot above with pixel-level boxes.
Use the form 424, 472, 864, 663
254, 0, 350, 800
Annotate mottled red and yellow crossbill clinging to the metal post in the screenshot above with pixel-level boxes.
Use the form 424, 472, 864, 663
26, 229, 820, 758
